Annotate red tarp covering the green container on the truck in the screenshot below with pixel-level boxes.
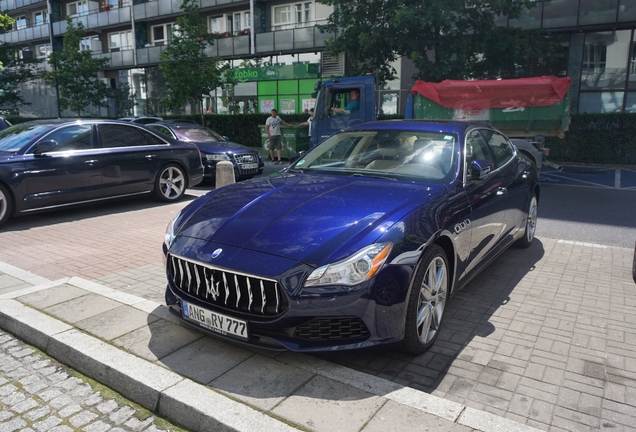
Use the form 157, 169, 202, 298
411, 76, 572, 109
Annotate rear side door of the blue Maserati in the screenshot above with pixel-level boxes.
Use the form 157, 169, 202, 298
480, 129, 532, 243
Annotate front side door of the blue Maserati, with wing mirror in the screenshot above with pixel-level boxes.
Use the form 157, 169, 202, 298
464, 129, 506, 272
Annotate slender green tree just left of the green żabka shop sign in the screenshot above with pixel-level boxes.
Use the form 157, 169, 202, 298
159, 0, 234, 124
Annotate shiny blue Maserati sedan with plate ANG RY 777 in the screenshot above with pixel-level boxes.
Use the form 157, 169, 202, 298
163, 121, 540, 354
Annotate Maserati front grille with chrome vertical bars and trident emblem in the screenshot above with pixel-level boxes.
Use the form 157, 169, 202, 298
168, 254, 289, 317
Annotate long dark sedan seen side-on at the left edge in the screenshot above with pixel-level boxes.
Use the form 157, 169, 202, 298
0, 119, 203, 224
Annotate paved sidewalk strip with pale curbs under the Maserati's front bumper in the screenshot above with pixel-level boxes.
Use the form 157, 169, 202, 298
0, 264, 536, 432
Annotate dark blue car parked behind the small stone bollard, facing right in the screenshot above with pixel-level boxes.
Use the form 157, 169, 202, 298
146, 121, 265, 180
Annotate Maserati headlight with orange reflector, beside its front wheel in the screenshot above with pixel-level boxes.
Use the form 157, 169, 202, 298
305, 243, 393, 287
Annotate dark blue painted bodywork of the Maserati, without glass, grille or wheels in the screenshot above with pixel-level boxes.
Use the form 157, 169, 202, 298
164, 121, 539, 351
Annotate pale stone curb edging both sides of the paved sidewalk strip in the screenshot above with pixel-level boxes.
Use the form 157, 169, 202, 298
0, 268, 539, 432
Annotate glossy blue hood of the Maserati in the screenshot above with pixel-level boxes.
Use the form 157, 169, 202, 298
176, 174, 446, 266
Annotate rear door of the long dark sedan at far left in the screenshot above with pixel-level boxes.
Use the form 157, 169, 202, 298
97, 123, 168, 197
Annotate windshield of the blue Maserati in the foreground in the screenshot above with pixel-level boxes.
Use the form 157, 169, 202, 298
290, 130, 459, 183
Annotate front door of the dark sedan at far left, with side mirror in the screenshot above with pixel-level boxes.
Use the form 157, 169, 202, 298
24, 124, 101, 209
